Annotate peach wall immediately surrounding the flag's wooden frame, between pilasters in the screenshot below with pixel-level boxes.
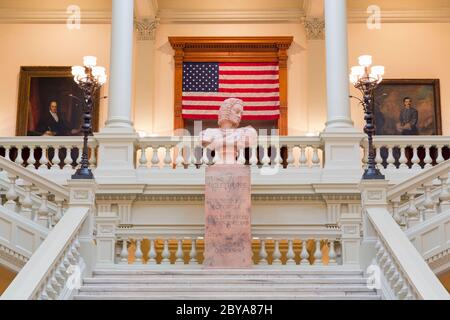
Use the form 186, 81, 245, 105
150, 23, 308, 135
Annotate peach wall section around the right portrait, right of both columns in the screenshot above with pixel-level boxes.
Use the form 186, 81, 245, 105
348, 23, 450, 135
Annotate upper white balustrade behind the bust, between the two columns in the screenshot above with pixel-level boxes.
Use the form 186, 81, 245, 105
136, 136, 322, 169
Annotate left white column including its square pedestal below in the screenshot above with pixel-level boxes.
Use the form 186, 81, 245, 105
94, 0, 137, 183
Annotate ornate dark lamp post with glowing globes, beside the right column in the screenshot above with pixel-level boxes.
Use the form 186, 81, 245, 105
350, 55, 384, 180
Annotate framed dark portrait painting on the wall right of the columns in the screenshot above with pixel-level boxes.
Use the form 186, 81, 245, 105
374, 79, 442, 135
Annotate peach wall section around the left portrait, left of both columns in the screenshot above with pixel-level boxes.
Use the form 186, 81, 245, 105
0, 24, 111, 136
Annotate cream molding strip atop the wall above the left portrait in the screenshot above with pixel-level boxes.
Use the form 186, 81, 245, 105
0, 9, 111, 24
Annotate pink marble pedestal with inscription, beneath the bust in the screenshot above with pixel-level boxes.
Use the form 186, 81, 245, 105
203, 164, 253, 268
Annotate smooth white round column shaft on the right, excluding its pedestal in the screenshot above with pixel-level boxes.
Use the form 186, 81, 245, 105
325, 0, 353, 132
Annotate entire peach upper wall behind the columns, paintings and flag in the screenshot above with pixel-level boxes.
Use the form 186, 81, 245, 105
0, 23, 450, 136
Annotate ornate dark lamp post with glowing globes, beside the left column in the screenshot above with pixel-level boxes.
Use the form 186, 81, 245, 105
72, 56, 106, 179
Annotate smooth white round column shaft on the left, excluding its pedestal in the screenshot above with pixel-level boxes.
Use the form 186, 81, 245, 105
104, 0, 134, 133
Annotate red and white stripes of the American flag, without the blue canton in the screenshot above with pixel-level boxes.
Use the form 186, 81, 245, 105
182, 62, 280, 120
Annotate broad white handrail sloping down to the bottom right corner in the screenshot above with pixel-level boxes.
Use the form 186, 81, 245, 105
366, 208, 450, 300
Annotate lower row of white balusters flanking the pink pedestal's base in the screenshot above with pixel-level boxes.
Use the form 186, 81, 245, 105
116, 233, 340, 266
